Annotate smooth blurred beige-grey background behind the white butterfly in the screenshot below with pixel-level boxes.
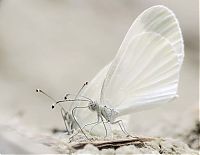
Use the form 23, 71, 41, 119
0, 0, 199, 152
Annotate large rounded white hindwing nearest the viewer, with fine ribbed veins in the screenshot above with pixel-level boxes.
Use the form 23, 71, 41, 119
102, 32, 180, 115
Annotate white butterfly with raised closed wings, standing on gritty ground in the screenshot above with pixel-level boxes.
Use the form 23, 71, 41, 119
69, 6, 184, 136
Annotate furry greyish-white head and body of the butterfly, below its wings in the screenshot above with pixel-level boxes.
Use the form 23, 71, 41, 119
88, 102, 119, 123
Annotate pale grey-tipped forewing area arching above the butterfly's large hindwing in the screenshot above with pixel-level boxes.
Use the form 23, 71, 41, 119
118, 5, 184, 65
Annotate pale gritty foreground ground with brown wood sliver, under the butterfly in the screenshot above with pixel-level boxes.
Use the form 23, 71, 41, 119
0, 119, 198, 155
